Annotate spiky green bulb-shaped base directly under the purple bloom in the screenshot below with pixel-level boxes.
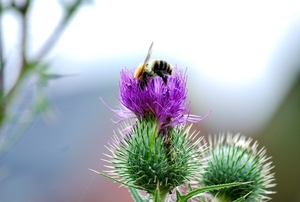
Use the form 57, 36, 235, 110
103, 116, 202, 198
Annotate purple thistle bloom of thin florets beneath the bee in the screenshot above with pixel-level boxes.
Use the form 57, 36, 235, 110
113, 68, 207, 129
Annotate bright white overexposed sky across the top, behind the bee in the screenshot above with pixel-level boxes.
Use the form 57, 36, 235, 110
3, 0, 300, 135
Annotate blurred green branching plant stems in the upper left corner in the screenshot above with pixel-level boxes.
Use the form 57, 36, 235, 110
0, 0, 87, 157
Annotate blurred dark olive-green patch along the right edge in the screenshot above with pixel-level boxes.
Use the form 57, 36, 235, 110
257, 70, 300, 202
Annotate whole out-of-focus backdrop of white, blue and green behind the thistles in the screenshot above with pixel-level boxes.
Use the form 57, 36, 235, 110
0, 0, 300, 202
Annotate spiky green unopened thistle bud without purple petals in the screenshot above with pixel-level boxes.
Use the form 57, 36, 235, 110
201, 133, 275, 202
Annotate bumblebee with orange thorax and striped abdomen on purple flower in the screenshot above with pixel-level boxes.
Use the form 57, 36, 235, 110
134, 42, 173, 90
